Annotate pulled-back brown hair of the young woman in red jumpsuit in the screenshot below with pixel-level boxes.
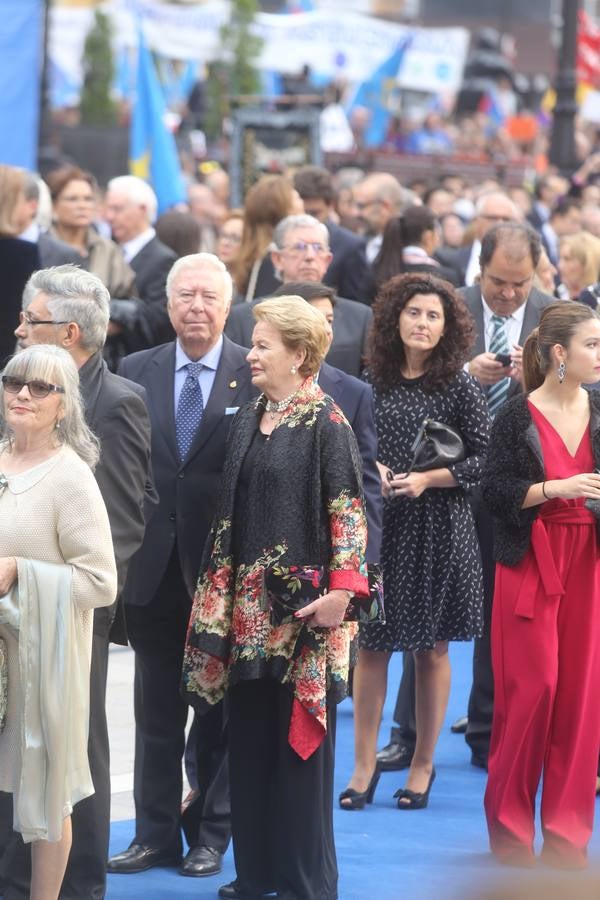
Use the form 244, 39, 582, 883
523, 300, 600, 392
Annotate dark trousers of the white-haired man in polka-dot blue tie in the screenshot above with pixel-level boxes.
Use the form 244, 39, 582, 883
126, 551, 231, 854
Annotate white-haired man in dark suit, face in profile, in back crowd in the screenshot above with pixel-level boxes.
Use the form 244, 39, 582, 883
104, 175, 177, 346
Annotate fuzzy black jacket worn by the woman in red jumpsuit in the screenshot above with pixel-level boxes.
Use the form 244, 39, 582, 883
481, 393, 600, 566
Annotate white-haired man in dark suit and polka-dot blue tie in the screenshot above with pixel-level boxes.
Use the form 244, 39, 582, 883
109, 253, 255, 876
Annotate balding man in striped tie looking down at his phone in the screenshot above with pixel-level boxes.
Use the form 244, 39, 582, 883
377, 222, 555, 771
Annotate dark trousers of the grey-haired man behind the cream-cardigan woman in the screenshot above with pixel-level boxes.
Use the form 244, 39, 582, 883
0, 609, 110, 900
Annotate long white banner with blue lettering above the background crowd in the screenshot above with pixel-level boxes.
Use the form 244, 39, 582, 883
49, 0, 469, 100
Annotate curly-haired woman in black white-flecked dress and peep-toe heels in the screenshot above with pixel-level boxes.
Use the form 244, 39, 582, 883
340, 274, 490, 809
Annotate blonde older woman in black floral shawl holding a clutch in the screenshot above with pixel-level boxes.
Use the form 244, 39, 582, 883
183, 297, 377, 900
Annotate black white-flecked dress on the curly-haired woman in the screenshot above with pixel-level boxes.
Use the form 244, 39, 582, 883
360, 372, 489, 651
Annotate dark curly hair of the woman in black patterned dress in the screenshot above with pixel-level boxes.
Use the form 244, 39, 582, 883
368, 272, 475, 392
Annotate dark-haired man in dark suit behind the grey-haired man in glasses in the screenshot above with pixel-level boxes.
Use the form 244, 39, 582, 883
294, 166, 373, 304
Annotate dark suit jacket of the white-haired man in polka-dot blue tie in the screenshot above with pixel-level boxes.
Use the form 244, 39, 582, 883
119, 339, 256, 606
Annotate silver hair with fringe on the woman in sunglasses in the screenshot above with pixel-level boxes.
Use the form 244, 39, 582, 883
0, 344, 100, 469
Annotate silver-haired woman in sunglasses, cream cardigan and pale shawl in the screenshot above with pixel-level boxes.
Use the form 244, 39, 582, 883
0, 344, 116, 900
